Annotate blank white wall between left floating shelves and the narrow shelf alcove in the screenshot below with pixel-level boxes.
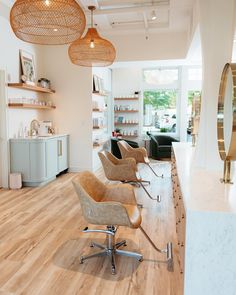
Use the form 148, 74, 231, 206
42, 46, 92, 171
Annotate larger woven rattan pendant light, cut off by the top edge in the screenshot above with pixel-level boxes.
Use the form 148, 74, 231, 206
10, 0, 86, 45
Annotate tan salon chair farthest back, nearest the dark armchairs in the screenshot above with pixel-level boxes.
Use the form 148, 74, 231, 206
117, 140, 163, 178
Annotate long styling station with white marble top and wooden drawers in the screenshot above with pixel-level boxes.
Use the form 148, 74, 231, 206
172, 143, 236, 295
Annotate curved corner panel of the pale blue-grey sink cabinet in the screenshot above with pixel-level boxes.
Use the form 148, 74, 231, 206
29, 142, 46, 182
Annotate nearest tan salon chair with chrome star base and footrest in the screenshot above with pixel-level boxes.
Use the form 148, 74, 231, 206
73, 171, 173, 274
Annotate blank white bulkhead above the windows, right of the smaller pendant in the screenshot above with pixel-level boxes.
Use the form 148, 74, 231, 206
108, 32, 188, 61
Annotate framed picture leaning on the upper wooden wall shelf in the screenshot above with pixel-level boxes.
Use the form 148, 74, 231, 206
20, 50, 36, 85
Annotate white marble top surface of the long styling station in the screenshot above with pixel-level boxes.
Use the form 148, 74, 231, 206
173, 143, 236, 214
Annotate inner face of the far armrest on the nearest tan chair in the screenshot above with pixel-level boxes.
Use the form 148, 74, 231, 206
102, 184, 137, 205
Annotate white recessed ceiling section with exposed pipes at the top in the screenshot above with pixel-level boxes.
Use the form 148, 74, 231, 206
77, 0, 195, 35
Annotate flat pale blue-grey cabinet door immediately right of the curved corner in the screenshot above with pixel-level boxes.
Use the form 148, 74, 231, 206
46, 138, 58, 178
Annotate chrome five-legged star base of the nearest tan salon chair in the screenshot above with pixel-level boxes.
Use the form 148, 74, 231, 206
80, 226, 143, 275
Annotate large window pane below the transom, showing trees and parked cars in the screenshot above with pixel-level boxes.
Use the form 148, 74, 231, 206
143, 90, 178, 132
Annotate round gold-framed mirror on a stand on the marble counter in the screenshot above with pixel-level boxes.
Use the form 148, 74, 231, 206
217, 63, 236, 183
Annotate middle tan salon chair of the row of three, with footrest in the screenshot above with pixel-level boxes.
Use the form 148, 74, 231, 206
98, 151, 161, 202
